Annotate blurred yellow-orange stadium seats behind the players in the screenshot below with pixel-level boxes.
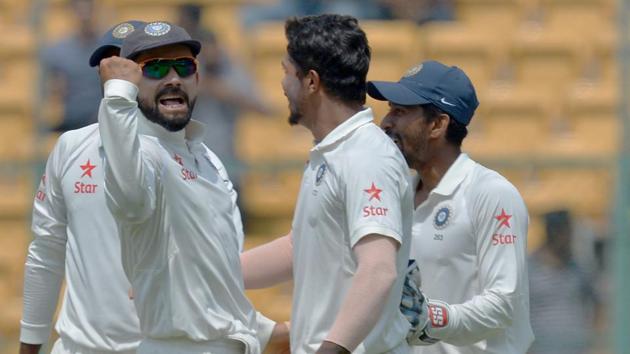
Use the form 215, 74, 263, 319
0, 0, 620, 353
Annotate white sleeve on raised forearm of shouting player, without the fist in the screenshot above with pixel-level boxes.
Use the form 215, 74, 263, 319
98, 80, 156, 217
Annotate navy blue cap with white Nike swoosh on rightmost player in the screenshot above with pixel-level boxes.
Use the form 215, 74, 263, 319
368, 60, 479, 125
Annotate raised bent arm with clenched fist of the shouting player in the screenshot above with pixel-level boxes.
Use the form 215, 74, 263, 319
98, 57, 159, 222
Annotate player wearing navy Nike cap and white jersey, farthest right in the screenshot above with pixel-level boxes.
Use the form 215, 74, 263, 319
368, 61, 533, 354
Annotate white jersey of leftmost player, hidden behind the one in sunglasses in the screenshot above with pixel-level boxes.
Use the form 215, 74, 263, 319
20, 124, 140, 352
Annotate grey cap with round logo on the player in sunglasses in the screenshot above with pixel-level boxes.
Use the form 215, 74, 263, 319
120, 21, 201, 60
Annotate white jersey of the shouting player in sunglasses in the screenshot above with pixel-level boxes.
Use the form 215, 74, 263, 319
99, 80, 260, 353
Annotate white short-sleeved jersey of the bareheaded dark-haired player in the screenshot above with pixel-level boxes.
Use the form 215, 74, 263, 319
291, 109, 413, 354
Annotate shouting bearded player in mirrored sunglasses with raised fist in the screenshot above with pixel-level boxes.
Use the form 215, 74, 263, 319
99, 22, 273, 354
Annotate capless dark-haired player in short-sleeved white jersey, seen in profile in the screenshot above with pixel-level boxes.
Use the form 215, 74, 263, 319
242, 15, 412, 354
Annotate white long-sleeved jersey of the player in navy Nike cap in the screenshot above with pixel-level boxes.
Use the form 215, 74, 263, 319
411, 154, 533, 354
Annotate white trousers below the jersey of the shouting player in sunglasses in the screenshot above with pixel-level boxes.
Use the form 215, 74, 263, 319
138, 338, 245, 354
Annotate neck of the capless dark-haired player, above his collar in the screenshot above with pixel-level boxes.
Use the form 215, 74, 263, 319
308, 100, 363, 141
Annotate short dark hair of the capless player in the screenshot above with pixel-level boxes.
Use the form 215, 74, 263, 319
285, 14, 370, 104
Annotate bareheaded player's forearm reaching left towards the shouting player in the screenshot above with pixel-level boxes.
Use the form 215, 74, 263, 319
241, 234, 293, 289
